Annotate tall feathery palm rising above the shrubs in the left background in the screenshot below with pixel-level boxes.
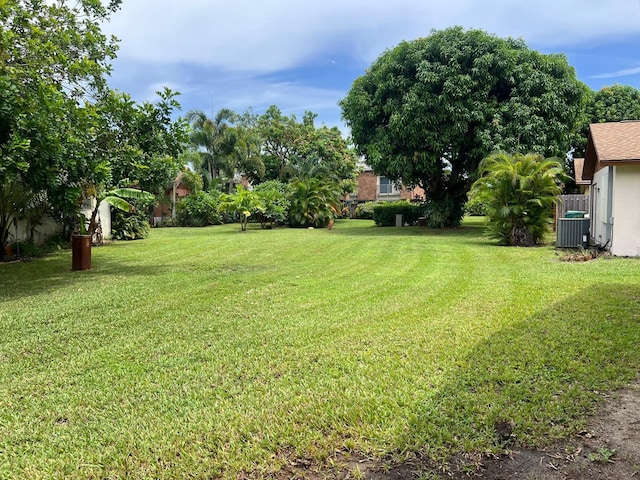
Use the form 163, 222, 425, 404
187, 108, 236, 188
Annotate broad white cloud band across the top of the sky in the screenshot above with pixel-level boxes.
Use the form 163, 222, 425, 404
107, 0, 640, 73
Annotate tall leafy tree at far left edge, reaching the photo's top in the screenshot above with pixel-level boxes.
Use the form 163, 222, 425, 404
0, 0, 120, 243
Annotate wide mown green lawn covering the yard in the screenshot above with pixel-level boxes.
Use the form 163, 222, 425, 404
0, 220, 640, 479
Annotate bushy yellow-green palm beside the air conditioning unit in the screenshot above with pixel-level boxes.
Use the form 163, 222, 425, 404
471, 153, 566, 247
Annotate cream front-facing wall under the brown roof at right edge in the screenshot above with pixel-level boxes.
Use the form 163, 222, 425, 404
611, 165, 640, 257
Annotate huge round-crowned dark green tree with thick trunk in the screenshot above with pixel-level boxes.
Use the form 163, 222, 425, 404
340, 27, 587, 226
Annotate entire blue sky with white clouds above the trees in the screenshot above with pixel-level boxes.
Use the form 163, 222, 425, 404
104, 0, 640, 130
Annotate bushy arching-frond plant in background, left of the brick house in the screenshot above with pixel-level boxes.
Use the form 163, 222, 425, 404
289, 177, 342, 227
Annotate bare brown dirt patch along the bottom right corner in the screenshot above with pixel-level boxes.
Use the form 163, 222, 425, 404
264, 383, 640, 480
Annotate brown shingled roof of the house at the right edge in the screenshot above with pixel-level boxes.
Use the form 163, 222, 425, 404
576, 121, 640, 180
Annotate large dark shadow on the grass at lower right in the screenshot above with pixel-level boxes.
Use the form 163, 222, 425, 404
395, 284, 640, 474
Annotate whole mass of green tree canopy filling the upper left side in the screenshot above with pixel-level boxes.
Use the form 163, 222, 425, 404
0, 0, 186, 244
